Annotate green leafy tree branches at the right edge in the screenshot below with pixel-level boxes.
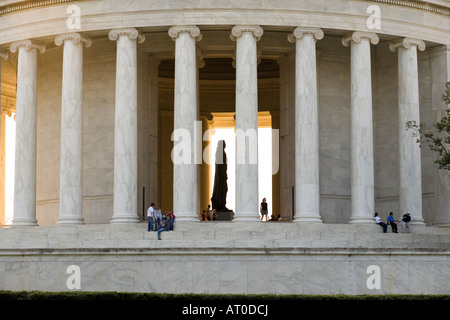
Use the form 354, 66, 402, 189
406, 82, 450, 170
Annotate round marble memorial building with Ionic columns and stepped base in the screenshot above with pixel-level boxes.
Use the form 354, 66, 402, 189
0, 0, 450, 294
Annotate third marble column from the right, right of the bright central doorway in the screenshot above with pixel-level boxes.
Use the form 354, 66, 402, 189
288, 27, 323, 222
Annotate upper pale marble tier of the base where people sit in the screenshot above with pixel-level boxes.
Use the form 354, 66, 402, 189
0, 222, 450, 250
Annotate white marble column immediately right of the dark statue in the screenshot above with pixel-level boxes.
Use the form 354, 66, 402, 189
231, 26, 263, 221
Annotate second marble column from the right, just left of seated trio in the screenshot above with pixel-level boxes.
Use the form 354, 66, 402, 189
342, 32, 379, 223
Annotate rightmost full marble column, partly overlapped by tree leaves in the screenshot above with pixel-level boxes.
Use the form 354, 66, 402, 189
389, 38, 425, 225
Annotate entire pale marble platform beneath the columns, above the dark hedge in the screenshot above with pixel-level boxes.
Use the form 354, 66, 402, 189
0, 221, 450, 294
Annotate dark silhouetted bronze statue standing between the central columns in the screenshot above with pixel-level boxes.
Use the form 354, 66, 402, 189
211, 140, 231, 212
